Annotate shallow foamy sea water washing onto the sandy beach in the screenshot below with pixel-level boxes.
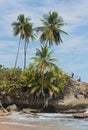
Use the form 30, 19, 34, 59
1, 112, 88, 130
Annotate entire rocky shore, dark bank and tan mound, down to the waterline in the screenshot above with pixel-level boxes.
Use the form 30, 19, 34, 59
0, 79, 88, 117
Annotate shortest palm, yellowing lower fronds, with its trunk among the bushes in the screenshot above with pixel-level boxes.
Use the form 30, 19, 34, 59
31, 45, 57, 98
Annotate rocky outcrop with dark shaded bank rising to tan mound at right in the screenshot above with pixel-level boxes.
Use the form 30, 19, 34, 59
1, 78, 88, 113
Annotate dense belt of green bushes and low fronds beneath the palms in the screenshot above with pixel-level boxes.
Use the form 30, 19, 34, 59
0, 64, 68, 100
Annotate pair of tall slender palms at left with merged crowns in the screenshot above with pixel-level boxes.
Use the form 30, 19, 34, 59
12, 14, 34, 69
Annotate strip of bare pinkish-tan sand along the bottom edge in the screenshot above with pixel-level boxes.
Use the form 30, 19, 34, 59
0, 122, 76, 130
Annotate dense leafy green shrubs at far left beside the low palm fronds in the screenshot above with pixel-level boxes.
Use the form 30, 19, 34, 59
0, 68, 22, 93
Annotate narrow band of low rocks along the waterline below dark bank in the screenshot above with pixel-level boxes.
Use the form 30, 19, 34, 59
0, 104, 88, 118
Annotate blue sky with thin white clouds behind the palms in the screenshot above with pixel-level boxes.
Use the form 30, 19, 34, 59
0, 0, 88, 82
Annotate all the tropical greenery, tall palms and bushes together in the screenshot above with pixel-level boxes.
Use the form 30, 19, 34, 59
0, 11, 69, 107
